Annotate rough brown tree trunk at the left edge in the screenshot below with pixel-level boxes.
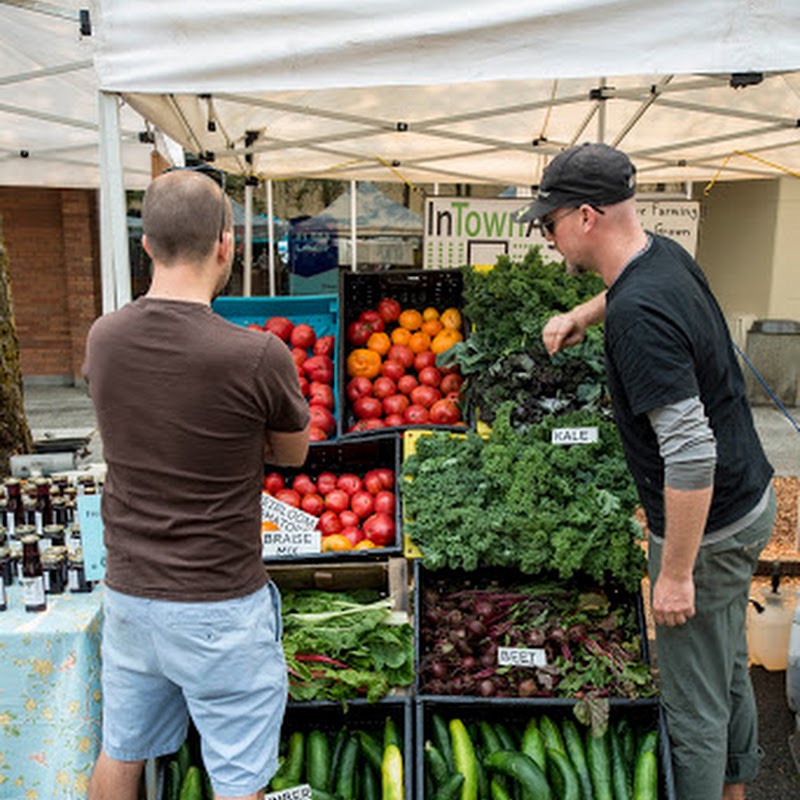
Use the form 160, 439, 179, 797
0, 219, 33, 475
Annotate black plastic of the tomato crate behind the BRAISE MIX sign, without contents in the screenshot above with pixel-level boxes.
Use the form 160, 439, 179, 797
265, 431, 403, 564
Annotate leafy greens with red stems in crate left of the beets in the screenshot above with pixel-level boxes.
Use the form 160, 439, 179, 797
283, 589, 414, 701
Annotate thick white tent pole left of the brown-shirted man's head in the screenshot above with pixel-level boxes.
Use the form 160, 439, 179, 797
98, 92, 131, 313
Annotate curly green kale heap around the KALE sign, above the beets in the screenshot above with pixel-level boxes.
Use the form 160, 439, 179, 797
400, 403, 644, 591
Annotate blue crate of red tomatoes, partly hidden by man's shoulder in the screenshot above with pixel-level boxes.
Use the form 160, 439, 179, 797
212, 295, 339, 442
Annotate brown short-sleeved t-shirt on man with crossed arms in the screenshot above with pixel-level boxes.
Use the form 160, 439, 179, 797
84, 298, 309, 601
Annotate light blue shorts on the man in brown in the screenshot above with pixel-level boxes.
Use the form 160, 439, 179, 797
102, 582, 288, 797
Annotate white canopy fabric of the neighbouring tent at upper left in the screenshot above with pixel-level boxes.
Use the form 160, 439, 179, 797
0, 0, 151, 188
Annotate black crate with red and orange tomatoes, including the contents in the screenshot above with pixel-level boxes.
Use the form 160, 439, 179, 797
339, 270, 467, 436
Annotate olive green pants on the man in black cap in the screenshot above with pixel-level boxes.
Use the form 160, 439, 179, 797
648, 491, 775, 800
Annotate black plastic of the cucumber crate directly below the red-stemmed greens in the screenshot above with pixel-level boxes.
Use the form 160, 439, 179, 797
274, 698, 417, 800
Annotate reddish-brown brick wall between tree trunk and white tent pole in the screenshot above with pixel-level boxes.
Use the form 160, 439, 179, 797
0, 187, 101, 383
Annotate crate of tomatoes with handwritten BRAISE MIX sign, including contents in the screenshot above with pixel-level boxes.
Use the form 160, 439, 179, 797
262, 434, 402, 561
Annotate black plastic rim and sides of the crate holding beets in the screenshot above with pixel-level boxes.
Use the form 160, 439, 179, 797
413, 560, 649, 702
